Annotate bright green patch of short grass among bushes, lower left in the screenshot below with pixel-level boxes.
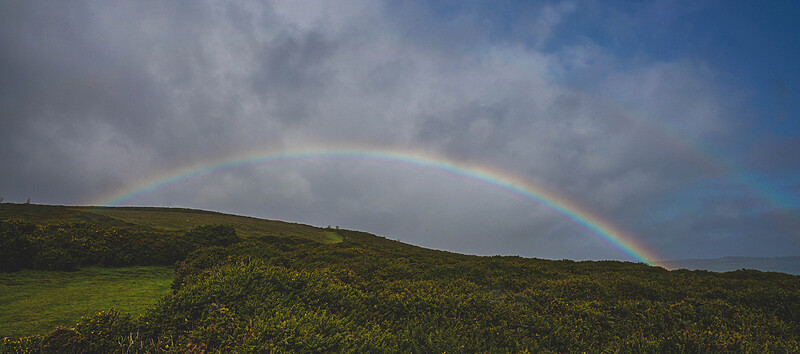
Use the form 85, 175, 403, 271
0, 266, 174, 337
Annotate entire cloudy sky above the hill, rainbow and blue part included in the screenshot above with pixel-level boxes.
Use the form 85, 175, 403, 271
0, 0, 800, 260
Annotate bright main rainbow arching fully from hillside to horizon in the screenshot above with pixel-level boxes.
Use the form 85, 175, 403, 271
91, 146, 660, 265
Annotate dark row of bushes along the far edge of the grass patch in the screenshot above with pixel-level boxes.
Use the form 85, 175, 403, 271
0, 220, 239, 271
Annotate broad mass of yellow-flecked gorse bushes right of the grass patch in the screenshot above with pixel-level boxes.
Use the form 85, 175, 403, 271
120, 238, 800, 353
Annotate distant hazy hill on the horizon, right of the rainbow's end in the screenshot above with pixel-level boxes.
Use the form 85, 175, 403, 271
660, 257, 800, 275
